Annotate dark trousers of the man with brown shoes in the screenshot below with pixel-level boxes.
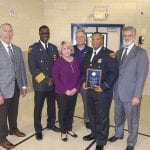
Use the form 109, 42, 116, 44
0, 84, 20, 143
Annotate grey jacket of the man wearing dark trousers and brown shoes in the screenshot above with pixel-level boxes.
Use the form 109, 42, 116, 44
0, 42, 27, 98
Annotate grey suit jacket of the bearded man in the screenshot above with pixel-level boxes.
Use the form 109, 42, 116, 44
114, 45, 149, 101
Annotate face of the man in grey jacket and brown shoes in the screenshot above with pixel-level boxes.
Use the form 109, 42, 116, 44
0, 24, 13, 44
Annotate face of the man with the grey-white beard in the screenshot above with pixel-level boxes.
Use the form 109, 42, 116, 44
123, 31, 135, 47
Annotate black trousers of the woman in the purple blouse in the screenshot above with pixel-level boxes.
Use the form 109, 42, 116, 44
57, 94, 77, 133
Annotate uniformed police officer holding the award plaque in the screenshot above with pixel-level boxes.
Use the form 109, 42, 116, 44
83, 32, 118, 150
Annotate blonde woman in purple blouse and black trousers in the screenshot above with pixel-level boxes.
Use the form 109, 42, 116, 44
52, 41, 81, 141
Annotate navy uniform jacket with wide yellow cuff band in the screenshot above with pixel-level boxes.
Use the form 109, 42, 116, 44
28, 41, 58, 91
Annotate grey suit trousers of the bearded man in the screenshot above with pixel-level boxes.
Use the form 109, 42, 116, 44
115, 99, 140, 146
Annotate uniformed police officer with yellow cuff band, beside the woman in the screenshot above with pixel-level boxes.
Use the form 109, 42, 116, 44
28, 25, 59, 140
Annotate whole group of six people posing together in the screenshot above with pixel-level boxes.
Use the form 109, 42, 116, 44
0, 23, 149, 150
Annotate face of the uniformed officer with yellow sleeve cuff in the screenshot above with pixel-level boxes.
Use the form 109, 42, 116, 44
39, 27, 50, 43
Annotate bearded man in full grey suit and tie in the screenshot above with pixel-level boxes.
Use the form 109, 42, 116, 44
109, 26, 149, 150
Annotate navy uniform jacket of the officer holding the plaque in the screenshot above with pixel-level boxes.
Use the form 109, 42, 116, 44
83, 47, 119, 91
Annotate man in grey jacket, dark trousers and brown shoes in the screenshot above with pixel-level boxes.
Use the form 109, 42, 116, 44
0, 23, 27, 149
